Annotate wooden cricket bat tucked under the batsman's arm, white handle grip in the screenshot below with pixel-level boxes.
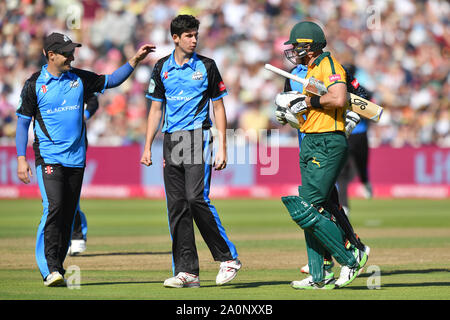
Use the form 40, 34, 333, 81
264, 63, 383, 122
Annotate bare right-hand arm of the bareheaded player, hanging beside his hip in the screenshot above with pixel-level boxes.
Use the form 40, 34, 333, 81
212, 99, 227, 170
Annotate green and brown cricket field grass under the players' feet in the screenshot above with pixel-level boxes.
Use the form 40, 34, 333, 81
0, 199, 450, 300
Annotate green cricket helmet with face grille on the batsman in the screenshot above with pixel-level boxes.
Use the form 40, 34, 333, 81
284, 21, 327, 64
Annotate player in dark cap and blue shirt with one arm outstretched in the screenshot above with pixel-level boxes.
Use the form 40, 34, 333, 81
16, 33, 155, 287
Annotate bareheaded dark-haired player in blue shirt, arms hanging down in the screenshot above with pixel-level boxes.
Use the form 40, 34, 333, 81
141, 15, 241, 288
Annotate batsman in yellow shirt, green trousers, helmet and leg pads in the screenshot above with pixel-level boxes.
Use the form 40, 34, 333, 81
282, 21, 368, 289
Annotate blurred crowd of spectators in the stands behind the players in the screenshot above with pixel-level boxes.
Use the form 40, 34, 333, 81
0, 0, 450, 147
